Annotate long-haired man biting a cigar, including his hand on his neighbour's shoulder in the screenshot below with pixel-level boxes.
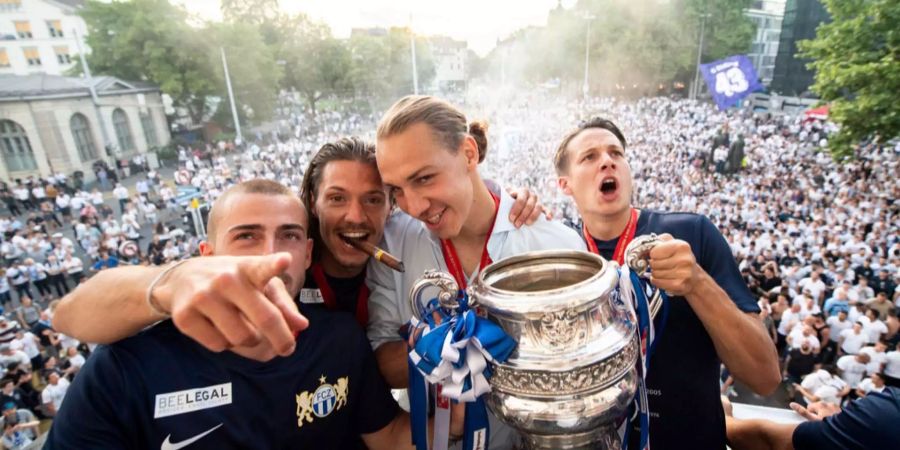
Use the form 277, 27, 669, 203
300, 137, 542, 327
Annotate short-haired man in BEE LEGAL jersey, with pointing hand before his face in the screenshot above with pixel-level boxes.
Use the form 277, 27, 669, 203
45, 180, 462, 449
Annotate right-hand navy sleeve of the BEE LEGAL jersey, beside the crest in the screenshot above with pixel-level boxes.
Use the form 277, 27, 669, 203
353, 324, 400, 434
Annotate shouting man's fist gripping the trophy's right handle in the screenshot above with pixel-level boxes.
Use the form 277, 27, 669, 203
650, 233, 703, 297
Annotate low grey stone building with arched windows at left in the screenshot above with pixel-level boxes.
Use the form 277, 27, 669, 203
0, 74, 170, 180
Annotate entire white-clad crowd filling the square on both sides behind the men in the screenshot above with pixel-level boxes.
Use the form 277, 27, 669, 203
0, 92, 900, 448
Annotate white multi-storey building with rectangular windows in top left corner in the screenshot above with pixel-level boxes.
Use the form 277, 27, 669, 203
0, 0, 87, 75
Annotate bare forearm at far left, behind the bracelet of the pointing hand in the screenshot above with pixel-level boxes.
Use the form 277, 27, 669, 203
53, 266, 165, 344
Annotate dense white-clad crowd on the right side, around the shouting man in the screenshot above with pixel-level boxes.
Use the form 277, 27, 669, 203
472, 92, 900, 408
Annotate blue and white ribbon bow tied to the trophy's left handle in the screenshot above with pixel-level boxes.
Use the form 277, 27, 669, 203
409, 291, 516, 450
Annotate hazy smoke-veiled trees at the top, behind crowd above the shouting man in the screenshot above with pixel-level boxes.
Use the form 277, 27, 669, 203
486, 0, 755, 92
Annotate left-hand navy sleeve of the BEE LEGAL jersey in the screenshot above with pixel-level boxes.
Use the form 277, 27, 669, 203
44, 346, 137, 450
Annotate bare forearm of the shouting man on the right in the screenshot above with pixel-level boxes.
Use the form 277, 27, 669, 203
685, 272, 781, 395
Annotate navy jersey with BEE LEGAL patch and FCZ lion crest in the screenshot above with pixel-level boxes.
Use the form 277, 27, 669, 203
45, 305, 398, 450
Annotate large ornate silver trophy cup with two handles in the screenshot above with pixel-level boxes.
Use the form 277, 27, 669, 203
410, 235, 662, 449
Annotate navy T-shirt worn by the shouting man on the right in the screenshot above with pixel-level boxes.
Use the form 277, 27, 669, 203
595, 210, 759, 449
